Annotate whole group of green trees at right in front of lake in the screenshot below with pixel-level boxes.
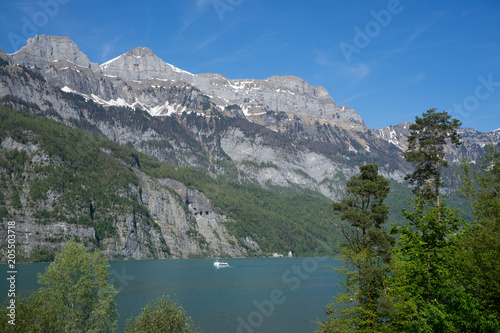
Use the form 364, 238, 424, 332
318, 109, 500, 333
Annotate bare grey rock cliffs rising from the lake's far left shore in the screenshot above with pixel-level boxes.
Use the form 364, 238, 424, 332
0, 134, 254, 260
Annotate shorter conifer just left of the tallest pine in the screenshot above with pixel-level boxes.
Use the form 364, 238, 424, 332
320, 164, 394, 332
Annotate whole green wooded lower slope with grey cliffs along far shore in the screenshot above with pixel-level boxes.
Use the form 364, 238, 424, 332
0, 108, 348, 259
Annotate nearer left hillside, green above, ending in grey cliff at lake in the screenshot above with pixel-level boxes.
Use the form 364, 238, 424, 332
0, 107, 252, 259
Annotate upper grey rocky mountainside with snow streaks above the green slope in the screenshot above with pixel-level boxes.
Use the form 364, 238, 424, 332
0, 36, 410, 198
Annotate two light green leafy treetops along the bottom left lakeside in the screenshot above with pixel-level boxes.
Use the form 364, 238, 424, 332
0, 240, 198, 333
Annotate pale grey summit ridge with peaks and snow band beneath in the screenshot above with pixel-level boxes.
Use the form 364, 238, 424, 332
4, 35, 368, 131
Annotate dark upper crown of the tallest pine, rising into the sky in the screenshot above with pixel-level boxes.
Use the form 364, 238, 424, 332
403, 108, 462, 206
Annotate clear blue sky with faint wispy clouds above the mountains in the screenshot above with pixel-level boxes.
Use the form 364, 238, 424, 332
0, 0, 500, 132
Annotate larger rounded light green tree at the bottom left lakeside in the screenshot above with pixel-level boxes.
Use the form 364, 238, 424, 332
38, 241, 118, 332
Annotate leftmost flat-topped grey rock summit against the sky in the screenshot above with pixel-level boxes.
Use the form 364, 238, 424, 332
12, 35, 91, 68
